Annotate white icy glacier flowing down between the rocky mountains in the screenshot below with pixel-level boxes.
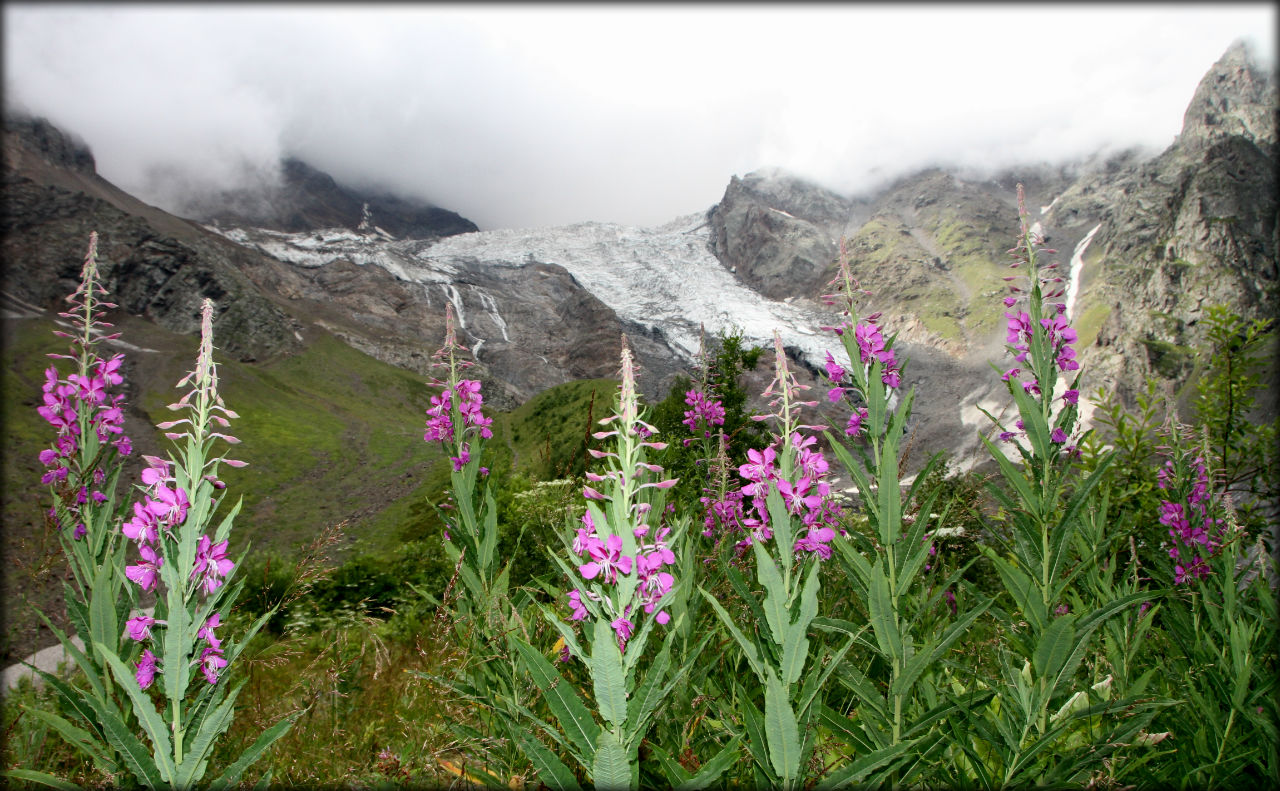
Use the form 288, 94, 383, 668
206, 212, 840, 367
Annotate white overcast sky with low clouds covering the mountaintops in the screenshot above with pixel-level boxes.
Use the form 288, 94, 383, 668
4, 3, 1276, 229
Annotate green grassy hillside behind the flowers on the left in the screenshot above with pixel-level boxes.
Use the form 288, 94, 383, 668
3, 311, 616, 659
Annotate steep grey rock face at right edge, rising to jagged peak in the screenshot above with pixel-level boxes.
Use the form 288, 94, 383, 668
1084, 45, 1280, 397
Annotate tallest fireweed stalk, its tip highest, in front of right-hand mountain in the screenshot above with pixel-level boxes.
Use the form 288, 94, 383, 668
954, 184, 1161, 787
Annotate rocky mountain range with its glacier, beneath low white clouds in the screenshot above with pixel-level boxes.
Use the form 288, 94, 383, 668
5, 39, 1277, 442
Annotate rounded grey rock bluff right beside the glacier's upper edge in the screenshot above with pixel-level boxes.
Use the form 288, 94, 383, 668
709, 170, 852, 300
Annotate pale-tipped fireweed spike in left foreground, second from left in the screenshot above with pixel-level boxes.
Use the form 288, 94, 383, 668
106, 300, 292, 786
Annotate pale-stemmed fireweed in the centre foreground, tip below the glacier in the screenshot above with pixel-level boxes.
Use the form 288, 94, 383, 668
511, 337, 706, 788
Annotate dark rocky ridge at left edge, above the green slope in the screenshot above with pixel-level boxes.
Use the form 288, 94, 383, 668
0, 119, 304, 360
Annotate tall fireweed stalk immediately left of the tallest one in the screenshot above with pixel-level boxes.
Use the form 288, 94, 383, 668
823, 244, 986, 783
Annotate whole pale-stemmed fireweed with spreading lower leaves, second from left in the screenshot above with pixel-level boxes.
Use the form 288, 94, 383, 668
17, 294, 292, 788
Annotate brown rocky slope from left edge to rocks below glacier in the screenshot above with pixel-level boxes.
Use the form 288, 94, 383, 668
0, 118, 672, 407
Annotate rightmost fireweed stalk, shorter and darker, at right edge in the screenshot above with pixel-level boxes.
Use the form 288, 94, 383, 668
1152, 422, 1280, 788
